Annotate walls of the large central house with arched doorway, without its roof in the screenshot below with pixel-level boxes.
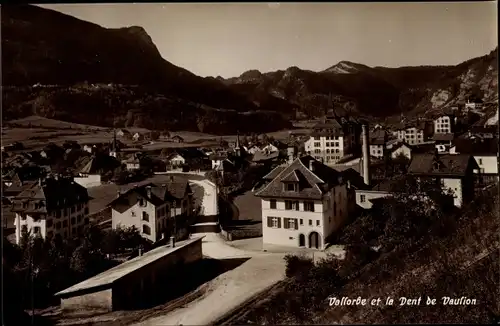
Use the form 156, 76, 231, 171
261, 185, 348, 250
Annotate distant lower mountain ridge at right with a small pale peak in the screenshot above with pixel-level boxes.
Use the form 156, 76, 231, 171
219, 46, 498, 117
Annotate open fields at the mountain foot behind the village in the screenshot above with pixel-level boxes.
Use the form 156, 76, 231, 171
2, 116, 309, 151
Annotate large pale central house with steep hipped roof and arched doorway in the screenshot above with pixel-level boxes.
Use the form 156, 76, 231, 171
255, 155, 355, 249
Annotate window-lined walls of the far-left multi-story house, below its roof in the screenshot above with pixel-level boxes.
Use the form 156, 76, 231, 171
14, 203, 89, 244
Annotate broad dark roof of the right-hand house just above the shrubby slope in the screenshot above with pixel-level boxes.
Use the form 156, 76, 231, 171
408, 154, 475, 176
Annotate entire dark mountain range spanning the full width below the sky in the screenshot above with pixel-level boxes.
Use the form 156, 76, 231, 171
2, 5, 498, 133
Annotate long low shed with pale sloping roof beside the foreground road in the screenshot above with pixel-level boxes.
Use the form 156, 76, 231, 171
55, 236, 204, 311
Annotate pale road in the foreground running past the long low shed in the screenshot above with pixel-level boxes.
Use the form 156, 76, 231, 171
137, 234, 285, 326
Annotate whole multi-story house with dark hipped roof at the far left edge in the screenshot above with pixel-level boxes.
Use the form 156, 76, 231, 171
12, 177, 89, 243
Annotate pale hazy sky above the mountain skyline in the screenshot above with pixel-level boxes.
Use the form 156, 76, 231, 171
40, 1, 498, 78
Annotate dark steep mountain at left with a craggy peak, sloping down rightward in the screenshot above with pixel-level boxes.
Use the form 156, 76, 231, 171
1, 5, 290, 133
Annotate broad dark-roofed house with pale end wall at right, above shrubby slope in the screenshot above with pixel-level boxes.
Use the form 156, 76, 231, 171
408, 154, 479, 207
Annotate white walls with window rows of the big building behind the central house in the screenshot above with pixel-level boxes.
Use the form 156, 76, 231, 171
304, 136, 354, 164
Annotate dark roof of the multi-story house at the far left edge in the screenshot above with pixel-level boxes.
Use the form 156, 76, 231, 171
13, 178, 90, 213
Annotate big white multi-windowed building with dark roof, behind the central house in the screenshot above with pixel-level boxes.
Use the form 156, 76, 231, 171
304, 117, 361, 164
